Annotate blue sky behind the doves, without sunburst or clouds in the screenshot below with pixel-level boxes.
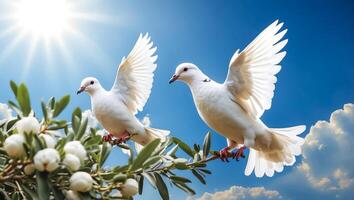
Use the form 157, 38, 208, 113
0, 0, 354, 199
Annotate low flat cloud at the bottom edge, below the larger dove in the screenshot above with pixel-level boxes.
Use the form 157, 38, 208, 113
198, 186, 282, 200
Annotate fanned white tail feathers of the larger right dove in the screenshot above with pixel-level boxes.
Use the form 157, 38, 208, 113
245, 126, 306, 177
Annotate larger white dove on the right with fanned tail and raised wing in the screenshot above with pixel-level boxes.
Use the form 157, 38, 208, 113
170, 20, 306, 177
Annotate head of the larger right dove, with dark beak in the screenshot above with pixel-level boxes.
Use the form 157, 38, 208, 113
169, 63, 205, 83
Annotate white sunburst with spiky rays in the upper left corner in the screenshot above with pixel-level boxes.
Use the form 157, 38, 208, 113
0, 0, 113, 77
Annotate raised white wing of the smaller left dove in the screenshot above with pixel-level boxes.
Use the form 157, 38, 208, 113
111, 34, 157, 114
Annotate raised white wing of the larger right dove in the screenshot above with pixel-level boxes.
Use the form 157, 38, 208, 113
224, 20, 288, 118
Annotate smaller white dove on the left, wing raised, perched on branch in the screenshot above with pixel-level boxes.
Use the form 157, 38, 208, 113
77, 34, 169, 147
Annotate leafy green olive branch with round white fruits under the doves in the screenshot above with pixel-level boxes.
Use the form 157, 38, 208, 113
0, 81, 239, 200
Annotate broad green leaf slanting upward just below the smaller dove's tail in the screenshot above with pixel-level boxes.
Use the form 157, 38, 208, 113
130, 139, 160, 171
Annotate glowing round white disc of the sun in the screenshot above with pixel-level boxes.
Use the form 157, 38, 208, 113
15, 0, 70, 37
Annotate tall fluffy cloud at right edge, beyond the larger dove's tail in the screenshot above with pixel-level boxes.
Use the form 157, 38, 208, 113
299, 104, 354, 193
